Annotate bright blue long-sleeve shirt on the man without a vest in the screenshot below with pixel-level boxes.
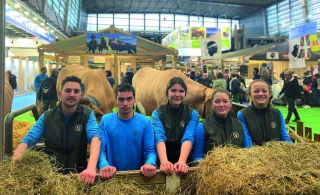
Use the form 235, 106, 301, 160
98, 113, 157, 171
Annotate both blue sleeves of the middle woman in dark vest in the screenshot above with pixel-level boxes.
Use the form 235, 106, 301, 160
152, 110, 199, 145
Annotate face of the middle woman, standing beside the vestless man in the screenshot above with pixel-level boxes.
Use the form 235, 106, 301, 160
168, 83, 186, 108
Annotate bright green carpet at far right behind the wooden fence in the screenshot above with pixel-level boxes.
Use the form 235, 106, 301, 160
275, 106, 320, 139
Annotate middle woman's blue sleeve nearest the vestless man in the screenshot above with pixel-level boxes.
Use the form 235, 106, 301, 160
151, 110, 167, 145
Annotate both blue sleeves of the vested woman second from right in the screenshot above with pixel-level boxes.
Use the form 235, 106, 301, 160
191, 122, 252, 161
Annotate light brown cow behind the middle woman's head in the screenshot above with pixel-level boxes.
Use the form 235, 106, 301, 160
132, 68, 213, 117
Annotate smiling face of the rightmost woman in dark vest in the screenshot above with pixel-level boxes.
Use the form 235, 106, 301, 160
249, 82, 270, 108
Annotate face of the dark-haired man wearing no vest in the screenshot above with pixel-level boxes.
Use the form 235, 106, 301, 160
117, 91, 135, 115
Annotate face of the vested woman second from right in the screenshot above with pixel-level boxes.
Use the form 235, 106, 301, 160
212, 93, 232, 118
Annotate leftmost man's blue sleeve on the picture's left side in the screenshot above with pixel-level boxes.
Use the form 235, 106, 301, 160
20, 114, 44, 148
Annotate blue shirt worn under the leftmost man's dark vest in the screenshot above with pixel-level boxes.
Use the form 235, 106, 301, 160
20, 111, 100, 148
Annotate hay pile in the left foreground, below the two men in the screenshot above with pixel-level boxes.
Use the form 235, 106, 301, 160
0, 151, 167, 195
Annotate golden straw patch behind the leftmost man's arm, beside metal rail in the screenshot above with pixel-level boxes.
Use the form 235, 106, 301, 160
12, 120, 33, 150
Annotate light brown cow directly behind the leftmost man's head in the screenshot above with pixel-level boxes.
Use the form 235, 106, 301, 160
57, 64, 115, 121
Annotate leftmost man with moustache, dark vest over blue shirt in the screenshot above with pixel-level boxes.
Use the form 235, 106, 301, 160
13, 76, 100, 183
